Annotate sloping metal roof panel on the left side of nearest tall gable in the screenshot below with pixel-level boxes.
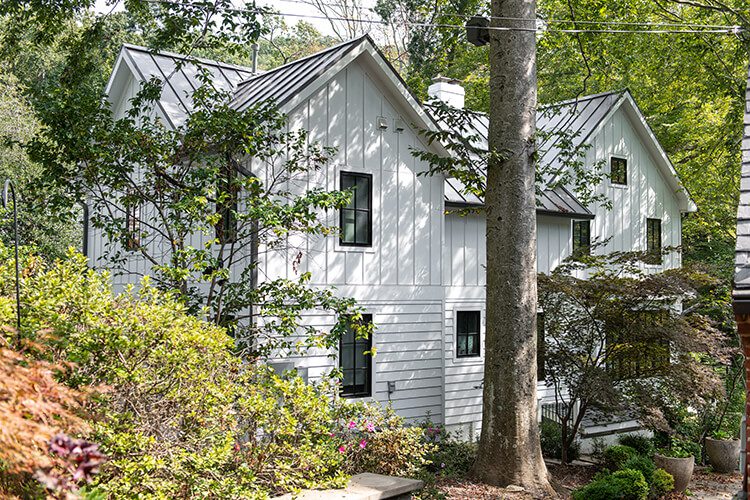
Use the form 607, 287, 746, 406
231, 35, 371, 110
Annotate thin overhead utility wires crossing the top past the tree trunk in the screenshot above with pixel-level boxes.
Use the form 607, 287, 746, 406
147, 0, 745, 35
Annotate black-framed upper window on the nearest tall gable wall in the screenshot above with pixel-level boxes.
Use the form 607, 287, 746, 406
339, 172, 372, 247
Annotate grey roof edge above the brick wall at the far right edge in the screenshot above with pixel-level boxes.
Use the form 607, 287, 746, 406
734, 64, 750, 302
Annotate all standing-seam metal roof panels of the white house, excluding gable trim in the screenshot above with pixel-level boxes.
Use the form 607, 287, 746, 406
124, 40, 625, 218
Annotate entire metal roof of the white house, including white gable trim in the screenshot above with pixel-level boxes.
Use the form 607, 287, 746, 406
107, 39, 695, 218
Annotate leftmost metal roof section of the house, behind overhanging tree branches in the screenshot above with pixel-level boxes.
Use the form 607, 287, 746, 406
123, 45, 253, 127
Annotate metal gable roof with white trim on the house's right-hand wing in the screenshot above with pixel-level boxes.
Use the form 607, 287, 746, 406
446, 89, 696, 215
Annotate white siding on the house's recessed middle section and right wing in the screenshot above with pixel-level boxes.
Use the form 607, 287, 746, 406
443, 103, 682, 438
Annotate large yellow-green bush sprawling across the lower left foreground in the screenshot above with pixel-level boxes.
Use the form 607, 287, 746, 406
0, 255, 434, 498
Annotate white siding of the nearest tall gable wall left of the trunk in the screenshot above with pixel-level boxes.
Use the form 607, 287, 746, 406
260, 57, 444, 422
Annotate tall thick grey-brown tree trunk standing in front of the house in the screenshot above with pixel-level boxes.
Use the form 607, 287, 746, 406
474, 0, 554, 494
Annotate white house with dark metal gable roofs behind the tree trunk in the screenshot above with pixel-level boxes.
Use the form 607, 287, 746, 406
94, 37, 695, 437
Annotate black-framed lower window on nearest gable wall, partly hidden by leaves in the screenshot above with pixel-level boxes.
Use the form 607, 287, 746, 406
339, 314, 372, 398
